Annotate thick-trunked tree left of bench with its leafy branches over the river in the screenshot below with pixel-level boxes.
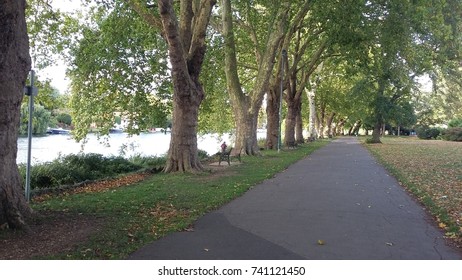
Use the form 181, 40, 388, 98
73, 0, 216, 172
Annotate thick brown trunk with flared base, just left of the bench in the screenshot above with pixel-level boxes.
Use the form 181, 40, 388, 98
158, 0, 216, 172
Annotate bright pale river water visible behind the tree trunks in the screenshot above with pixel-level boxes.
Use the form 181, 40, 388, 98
17, 132, 266, 164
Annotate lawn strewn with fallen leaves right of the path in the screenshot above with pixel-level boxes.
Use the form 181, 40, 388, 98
365, 137, 462, 246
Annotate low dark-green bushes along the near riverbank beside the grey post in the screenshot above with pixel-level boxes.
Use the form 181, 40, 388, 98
19, 154, 142, 189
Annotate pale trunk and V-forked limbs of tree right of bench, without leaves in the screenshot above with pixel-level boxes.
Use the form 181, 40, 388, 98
222, 0, 292, 155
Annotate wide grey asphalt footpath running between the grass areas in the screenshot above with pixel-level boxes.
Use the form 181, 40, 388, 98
129, 137, 462, 260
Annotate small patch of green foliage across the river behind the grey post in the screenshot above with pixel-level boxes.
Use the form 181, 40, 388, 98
19, 103, 51, 136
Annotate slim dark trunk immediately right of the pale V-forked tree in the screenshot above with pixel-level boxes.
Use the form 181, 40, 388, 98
266, 87, 280, 150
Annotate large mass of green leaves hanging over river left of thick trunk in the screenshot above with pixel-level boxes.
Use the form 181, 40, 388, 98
69, 1, 172, 139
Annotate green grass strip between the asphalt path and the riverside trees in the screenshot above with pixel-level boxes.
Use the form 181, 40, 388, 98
32, 141, 329, 259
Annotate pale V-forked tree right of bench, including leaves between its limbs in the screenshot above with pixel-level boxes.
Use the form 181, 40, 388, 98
221, 0, 318, 155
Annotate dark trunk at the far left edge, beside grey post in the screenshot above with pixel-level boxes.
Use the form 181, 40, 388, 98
0, 0, 32, 229
